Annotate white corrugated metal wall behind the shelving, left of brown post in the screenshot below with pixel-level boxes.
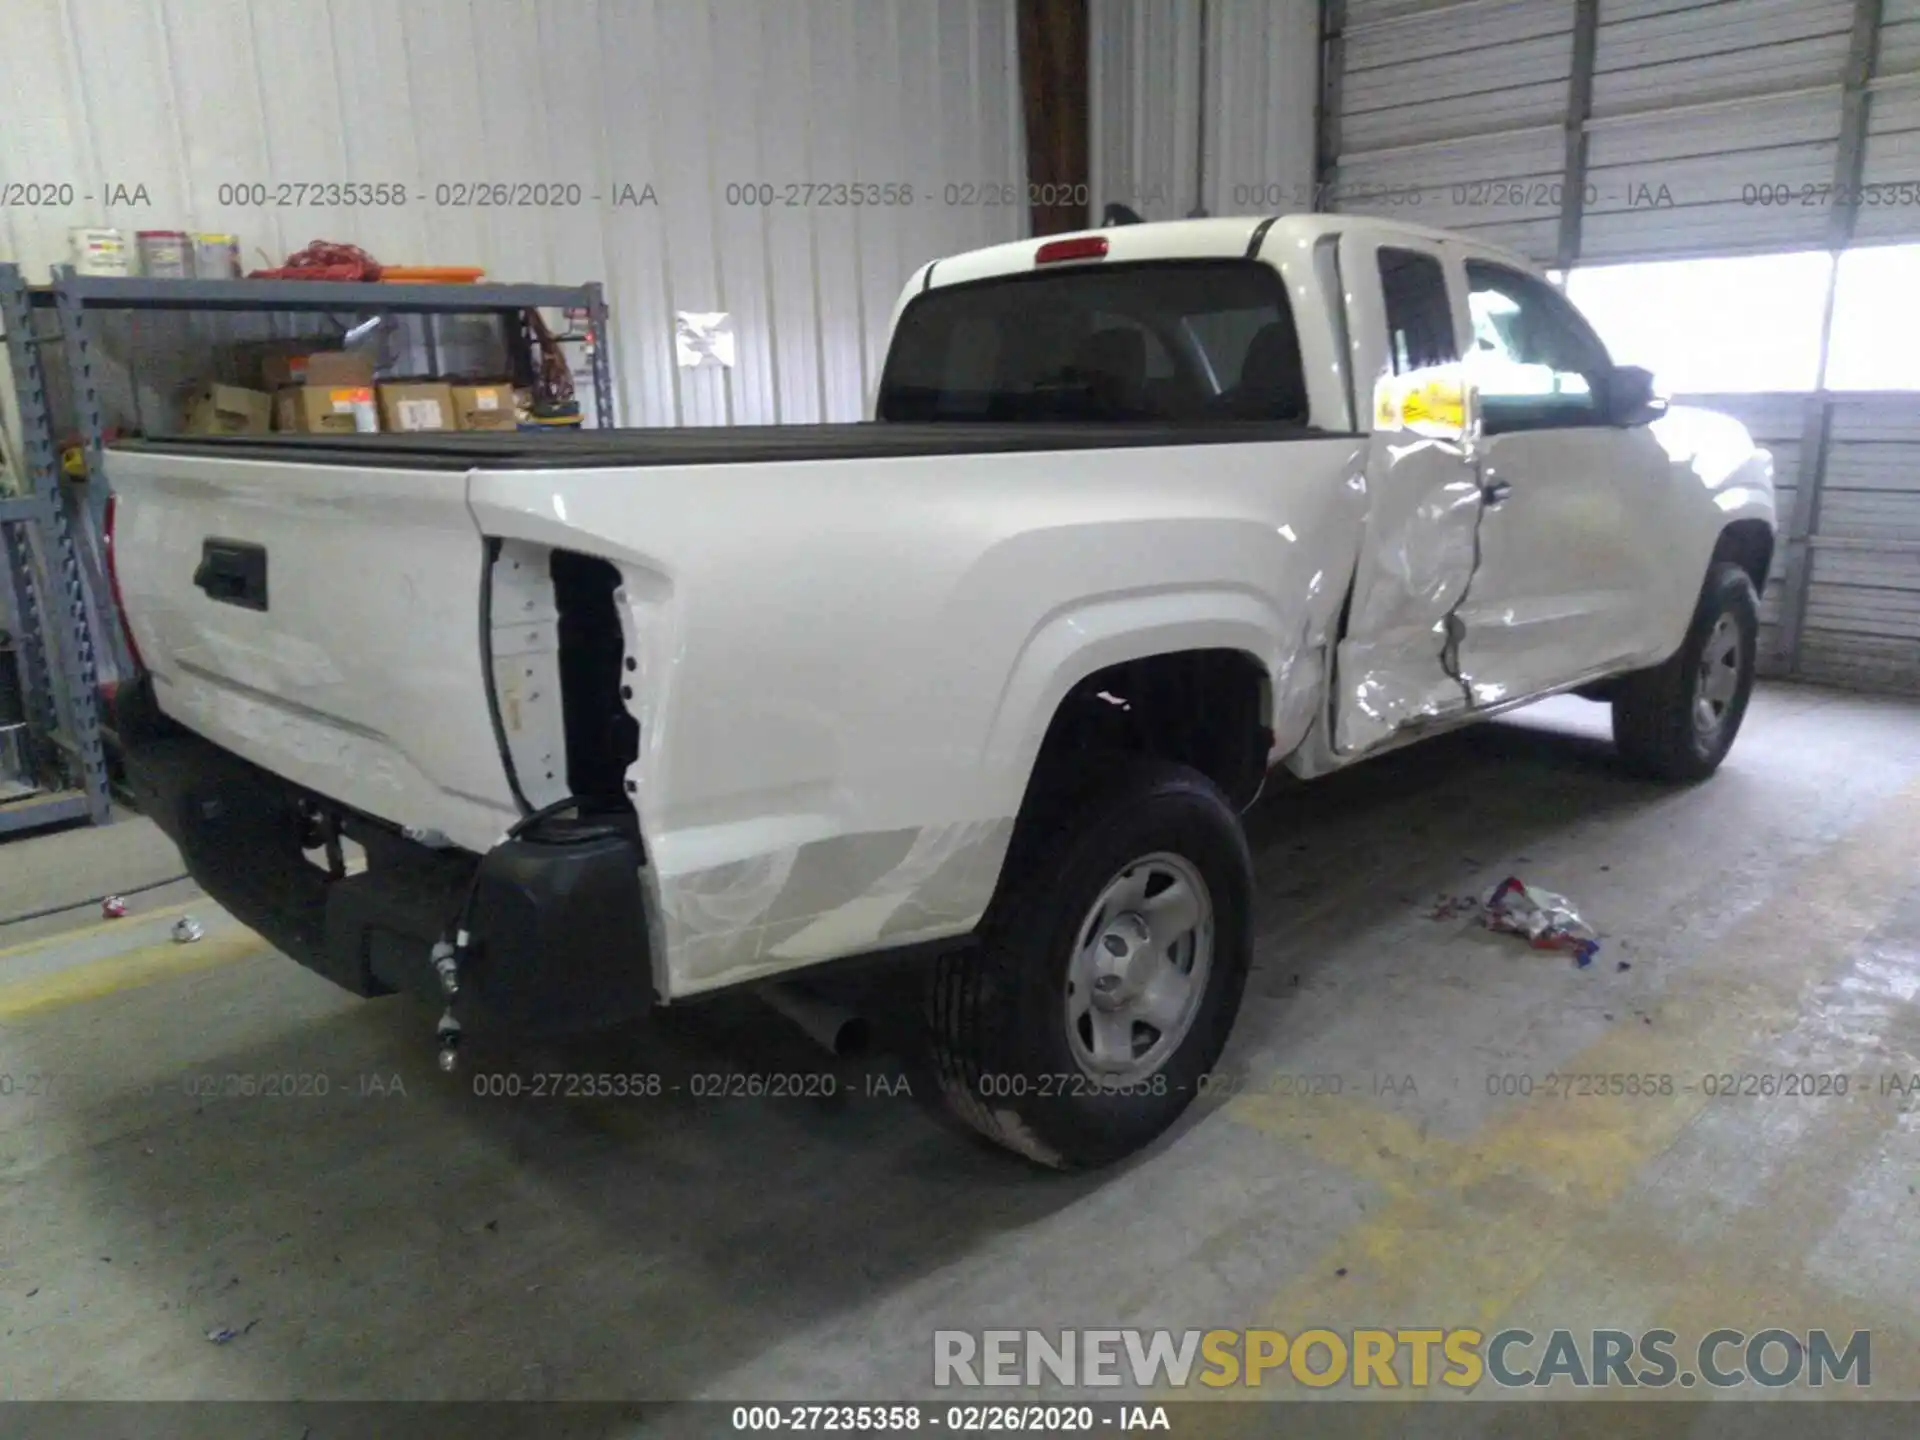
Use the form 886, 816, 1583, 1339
0, 0, 1025, 424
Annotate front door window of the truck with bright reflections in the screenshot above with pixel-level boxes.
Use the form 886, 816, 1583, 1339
1467, 259, 1609, 434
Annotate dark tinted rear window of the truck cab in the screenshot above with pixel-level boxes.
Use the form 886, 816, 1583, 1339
879, 259, 1308, 424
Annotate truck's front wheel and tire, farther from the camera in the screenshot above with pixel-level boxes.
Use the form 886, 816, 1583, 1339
1613, 561, 1761, 783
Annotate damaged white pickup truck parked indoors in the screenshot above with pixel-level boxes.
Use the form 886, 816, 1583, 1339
108, 215, 1774, 1165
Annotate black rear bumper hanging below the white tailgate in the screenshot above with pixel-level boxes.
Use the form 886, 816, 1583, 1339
113, 678, 655, 1033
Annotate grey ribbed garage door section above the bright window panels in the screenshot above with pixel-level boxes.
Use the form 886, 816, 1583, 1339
1334, 0, 1920, 265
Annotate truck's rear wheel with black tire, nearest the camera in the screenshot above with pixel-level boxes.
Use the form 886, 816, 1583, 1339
927, 758, 1254, 1169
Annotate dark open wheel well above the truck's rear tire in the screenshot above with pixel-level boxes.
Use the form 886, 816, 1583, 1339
1027, 651, 1273, 808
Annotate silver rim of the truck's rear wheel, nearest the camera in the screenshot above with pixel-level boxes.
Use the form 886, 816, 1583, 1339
1066, 851, 1213, 1083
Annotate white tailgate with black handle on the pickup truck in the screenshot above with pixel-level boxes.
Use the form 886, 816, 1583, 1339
108, 451, 518, 849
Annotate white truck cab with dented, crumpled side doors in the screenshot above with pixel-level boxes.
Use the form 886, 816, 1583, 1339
876, 215, 1774, 774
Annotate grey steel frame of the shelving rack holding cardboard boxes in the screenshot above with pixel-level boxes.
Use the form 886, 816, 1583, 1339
0, 263, 618, 835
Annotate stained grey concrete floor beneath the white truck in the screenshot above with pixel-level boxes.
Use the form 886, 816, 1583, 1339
0, 687, 1920, 1400
